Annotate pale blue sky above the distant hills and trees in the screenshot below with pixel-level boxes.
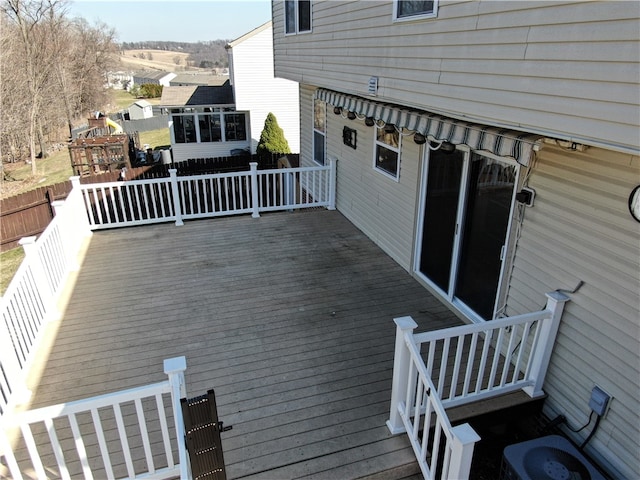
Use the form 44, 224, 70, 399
68, 0, 271, 42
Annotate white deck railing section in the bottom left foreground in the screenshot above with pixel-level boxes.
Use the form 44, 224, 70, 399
0, 357, 190, 480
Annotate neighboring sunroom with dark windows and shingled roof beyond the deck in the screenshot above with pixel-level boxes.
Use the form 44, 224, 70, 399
160, 83, 251, 162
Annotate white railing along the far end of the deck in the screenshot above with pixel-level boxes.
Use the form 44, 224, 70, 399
80, 161, 336, 230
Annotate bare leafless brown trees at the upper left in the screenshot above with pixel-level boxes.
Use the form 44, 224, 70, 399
0, 0, 119, 175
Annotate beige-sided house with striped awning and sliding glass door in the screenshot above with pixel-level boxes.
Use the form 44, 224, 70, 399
272, 0, 640, 478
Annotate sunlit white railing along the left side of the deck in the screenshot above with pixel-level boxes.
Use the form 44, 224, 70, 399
0, 177, 91, 416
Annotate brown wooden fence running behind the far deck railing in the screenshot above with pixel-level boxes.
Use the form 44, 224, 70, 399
0, 154, 299, 252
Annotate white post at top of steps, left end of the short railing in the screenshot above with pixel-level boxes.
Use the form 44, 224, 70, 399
387, 317, 418, 435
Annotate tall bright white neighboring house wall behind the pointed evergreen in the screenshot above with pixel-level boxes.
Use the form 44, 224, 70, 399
227, 21, 300, 153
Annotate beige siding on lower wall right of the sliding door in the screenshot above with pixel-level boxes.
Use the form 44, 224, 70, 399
507, 145, 640, 478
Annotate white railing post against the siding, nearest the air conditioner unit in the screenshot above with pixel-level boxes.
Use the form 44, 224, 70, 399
523, 291, 569, 397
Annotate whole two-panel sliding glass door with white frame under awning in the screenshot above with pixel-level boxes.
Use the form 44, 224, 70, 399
416, 150, 517, 320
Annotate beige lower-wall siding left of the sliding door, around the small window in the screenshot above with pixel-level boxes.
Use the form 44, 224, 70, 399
301, 88, 420, 271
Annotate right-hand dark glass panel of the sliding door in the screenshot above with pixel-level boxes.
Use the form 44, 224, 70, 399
455, 154, 517, 319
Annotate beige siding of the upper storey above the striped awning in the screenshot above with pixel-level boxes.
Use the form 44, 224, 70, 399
273, 0, 640, 151
